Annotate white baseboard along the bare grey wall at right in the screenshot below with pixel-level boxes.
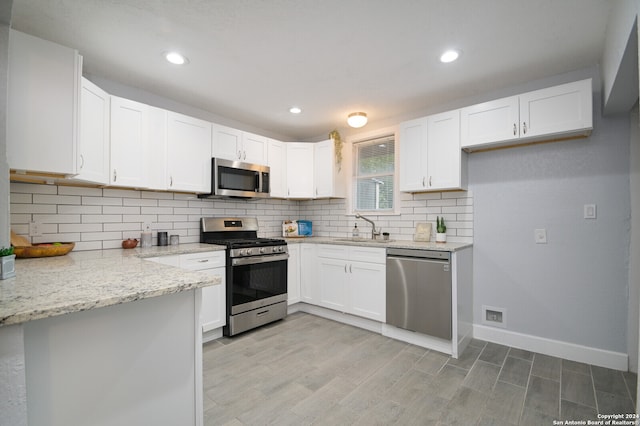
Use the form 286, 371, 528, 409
473, 324, 629, 371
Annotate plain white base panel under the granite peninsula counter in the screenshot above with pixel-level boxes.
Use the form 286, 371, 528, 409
24, 289, 203, 426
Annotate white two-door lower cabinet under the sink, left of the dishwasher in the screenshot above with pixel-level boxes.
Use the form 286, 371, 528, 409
317, 244, 386, 322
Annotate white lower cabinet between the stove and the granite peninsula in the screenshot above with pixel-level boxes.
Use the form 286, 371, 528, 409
147, 250, 227, 333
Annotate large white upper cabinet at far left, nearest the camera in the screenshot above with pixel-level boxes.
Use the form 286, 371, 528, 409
7, 30, 82, 175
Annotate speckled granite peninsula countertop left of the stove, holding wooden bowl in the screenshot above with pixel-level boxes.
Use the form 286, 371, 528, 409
0, 244, 225, 326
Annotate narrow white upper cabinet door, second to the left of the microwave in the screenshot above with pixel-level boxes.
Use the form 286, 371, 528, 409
144, 106, 168, 190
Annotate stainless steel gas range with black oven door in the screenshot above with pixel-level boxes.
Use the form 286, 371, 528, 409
200, 217, 289, 336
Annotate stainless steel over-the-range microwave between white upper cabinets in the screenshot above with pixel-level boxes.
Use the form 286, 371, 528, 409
199, 158, 270, 198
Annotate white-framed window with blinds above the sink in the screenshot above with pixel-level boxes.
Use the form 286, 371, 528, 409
353, 136, 395, 212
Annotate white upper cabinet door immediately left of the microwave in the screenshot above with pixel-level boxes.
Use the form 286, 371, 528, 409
167, 112, 211, 193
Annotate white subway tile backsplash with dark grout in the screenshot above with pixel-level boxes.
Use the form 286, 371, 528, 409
11, 183, 473, 250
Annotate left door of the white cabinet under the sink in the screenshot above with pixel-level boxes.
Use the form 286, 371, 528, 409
318, 258, 347, 312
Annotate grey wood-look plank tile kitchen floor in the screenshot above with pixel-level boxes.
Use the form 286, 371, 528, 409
203, 313, 637, 426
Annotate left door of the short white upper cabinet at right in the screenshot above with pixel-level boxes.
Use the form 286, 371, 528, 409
461, 96, 520, 148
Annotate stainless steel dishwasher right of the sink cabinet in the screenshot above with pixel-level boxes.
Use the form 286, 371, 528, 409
387, 248, 451, 340
